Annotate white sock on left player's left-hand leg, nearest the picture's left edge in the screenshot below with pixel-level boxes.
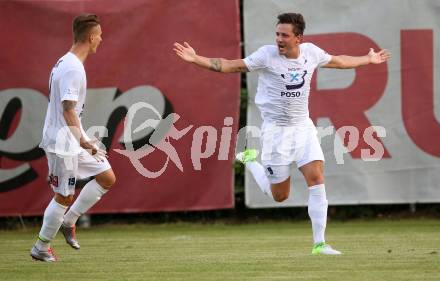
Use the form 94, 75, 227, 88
35, 199, 67, 251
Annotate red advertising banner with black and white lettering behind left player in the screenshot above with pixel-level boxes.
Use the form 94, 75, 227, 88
0, 0, 240, 216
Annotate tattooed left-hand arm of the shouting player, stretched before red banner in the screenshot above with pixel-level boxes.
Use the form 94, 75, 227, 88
173, 42, 248, 73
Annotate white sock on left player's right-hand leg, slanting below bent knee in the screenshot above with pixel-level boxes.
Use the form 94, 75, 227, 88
63, 179, 108, 226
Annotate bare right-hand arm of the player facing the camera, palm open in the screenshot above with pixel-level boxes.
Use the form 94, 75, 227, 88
323, 48, 391, 68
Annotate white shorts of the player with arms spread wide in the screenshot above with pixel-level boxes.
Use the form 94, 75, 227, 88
261, 118, 324, 184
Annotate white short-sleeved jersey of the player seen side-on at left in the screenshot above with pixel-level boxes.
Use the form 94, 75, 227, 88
40, 52, 87, 155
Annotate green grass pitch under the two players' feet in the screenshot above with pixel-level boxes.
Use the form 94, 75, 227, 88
0, 220, 440, 281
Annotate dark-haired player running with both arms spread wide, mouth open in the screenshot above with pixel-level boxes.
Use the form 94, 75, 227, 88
174, 13, 390, 255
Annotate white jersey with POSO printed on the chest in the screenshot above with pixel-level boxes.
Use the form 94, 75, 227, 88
243, 43, 331, 126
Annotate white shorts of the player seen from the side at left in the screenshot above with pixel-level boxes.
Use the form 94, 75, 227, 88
46, 149, 111, 196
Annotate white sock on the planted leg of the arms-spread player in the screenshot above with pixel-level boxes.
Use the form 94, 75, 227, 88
308, 184, 328, 244
